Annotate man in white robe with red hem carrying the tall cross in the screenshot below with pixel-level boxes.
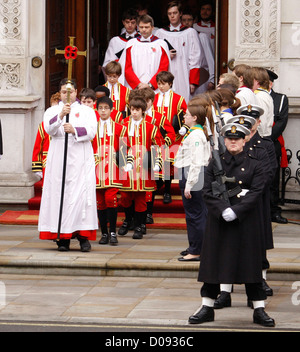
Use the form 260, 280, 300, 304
38, 79, 98, 252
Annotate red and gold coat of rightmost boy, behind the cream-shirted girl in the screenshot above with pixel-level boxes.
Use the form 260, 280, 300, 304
153, 90, 187, 161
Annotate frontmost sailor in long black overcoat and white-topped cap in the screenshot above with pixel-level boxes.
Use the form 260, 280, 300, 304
189, 124, 275, 326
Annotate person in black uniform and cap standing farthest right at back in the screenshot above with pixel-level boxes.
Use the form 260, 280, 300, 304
267, 70, 289, 224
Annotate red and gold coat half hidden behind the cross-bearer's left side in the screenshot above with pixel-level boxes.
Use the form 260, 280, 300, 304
32, 122, 51, 175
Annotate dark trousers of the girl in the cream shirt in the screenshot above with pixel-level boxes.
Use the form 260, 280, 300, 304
179, 169, 207, 255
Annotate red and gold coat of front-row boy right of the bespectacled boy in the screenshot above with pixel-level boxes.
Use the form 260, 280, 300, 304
122, 117, 162, 192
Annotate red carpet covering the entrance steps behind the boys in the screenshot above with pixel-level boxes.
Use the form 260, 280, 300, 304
0, 181, 186, 230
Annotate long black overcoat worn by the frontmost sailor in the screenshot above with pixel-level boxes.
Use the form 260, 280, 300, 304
198, 151, 265, 284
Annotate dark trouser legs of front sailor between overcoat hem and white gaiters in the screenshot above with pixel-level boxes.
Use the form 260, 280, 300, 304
200, 282, 267, 301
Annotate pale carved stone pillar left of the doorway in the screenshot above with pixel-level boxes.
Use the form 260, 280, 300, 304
0, 0, 45, 204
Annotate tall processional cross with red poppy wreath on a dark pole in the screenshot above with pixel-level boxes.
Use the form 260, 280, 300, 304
55, 37, 86, 242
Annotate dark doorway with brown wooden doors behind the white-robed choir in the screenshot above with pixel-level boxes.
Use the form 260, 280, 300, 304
46, 0, 228, 107
